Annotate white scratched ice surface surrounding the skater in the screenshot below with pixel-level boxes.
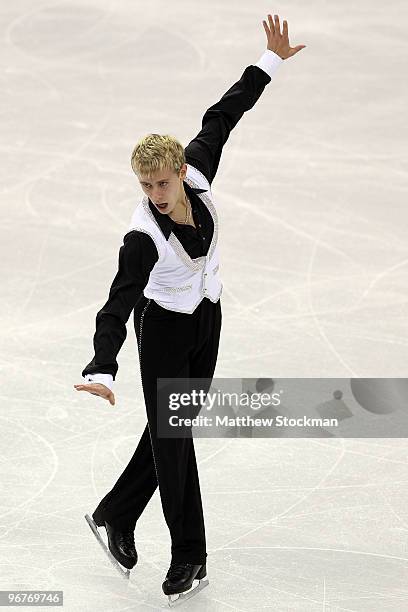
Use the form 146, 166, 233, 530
0, 0, 408, 612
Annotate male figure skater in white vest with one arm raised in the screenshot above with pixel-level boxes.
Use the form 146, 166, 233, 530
74, 15, 305, 605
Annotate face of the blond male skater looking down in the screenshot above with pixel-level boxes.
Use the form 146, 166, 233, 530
138, 164, 187, 215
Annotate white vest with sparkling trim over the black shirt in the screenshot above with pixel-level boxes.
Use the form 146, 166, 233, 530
128, 164, 223, 314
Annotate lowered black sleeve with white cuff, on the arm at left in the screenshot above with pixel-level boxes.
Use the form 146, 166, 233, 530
82, 230, 158, 386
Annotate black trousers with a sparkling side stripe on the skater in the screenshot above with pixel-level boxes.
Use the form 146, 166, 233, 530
93, 296, 222, 564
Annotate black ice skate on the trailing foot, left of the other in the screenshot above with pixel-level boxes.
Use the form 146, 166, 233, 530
85, 513, 137, 579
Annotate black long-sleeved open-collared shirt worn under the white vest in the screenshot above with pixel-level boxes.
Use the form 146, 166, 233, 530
82, 65, 271, 379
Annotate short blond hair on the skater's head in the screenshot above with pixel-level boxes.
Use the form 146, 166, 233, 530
130, 134, 186, 178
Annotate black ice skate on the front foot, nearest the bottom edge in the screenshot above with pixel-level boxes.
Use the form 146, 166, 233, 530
162, 563, 209, 607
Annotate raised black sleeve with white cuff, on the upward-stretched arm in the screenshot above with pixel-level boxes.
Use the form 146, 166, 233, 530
185, 49, 284, 185
